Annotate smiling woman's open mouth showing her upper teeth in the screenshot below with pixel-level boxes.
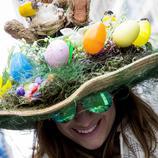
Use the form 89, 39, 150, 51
73, 120, 101, 135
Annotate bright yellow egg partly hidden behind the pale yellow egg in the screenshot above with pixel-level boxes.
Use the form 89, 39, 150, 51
133, 19, 151, 47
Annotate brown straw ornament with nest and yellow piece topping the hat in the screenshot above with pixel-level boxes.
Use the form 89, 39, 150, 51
4, 0, 90, 43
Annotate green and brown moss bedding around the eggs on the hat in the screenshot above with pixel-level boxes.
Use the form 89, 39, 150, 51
0, 38, 154, 110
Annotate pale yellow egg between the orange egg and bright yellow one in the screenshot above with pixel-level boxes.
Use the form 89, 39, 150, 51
112, 20, 140, 47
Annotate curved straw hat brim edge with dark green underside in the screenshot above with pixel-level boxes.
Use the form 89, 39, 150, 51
0, 53, 158, 129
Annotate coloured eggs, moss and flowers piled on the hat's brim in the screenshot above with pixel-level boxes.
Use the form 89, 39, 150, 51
0, 10, 152, 110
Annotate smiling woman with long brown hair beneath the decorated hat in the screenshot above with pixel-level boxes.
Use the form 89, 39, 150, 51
33, 87, 158, 158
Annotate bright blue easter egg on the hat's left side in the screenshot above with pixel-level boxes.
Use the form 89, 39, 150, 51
10, 53, 33, 83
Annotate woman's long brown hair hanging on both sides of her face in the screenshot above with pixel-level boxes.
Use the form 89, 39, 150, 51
33, 87, 158, 158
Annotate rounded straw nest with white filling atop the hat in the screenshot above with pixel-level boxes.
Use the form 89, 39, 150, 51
29, 3, 66, 35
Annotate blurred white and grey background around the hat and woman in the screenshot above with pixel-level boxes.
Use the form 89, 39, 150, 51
0, 0, 158, 158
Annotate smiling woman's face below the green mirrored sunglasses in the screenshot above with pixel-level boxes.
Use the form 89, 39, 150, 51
57, 102, 115, 150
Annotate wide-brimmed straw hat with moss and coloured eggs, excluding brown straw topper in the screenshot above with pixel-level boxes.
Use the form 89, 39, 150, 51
0, 17, 158, 129
